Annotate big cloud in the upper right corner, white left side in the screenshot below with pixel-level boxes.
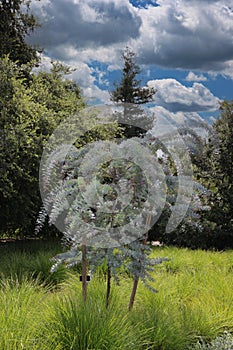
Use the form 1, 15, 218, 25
134, 0, 233, 75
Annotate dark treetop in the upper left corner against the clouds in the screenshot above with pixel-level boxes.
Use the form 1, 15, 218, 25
0, 0, 38, 64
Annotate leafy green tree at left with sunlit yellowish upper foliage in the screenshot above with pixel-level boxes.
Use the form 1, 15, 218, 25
0, 57, 84, 236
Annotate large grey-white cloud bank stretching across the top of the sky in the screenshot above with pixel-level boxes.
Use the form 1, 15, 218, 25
30, 0, 233, 78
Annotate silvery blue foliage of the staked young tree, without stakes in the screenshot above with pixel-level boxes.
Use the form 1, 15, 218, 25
37, 139, 167, 285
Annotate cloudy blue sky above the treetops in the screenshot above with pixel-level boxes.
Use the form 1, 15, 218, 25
29, 0, 233, 123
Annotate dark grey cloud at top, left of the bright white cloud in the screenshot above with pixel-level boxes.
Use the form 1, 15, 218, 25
30, 0, 141, 51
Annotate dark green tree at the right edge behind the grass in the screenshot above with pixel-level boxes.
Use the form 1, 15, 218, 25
150, 101, 233, 249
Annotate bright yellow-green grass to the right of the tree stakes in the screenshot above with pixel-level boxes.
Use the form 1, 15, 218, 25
130, 249, 233, 350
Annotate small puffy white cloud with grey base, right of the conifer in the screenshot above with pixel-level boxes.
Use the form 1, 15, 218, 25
147, 79, 219, 112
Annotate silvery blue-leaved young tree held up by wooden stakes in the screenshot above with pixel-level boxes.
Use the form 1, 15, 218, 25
37, 108, 182, 309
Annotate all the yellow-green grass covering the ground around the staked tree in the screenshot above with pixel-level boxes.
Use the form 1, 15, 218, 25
0, 245, 233, 350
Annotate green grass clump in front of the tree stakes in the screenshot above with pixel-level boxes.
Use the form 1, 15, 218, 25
39, 278, 147, 350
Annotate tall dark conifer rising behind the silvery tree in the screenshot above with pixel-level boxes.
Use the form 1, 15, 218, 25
110, 47, 156, 137
